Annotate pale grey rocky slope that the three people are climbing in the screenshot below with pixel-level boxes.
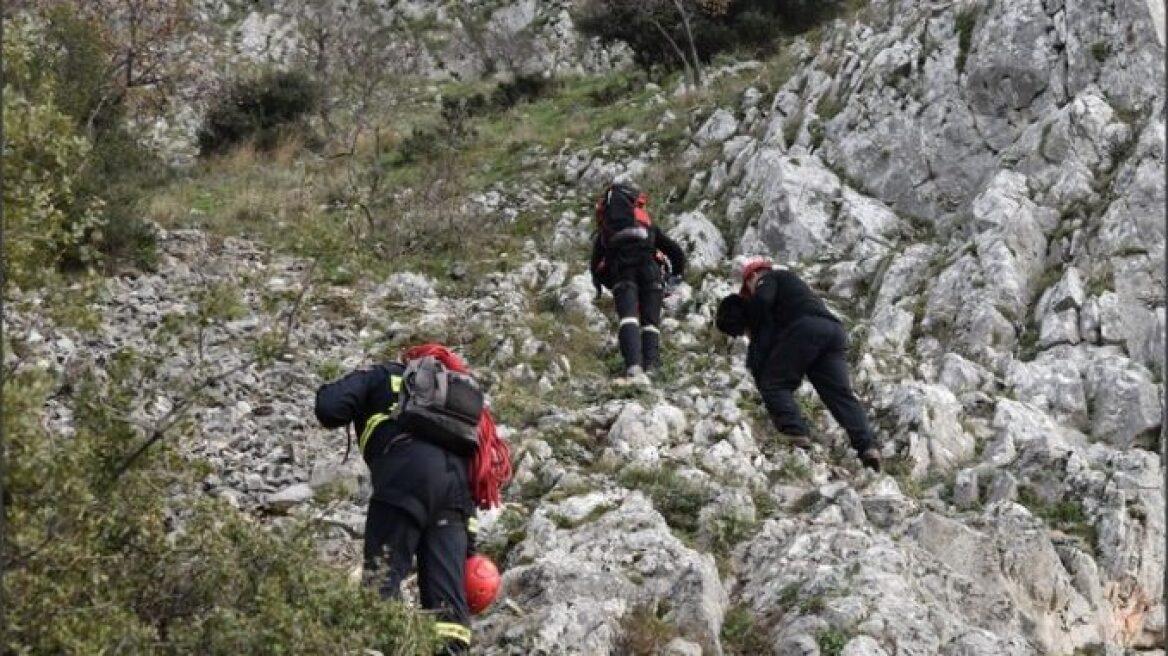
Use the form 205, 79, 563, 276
5, 0, 1166, 656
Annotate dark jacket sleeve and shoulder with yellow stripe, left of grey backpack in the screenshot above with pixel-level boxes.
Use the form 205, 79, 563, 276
315, 362, 405, 461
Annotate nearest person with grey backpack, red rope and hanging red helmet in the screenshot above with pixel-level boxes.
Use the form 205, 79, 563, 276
315, 344, 510, 654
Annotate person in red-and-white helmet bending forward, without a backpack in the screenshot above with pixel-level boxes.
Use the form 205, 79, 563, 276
715, 258, 881, 472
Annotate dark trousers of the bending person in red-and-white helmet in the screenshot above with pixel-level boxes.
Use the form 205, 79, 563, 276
755, 316, 874, 452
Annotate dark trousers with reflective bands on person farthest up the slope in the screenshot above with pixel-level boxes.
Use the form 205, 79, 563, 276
612, 256, 665, 369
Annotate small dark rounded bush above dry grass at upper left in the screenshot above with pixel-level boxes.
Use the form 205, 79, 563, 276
199, 70, 321, 155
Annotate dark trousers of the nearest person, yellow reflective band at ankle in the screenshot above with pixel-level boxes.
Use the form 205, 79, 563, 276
364, 437, 473, 654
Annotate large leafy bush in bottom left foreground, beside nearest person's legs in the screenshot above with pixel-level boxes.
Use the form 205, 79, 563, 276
0, 354, 432, 655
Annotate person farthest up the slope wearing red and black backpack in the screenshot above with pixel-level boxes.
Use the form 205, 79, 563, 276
589, 183, 686, 377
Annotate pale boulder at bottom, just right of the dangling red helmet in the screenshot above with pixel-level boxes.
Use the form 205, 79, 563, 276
479, 490, 728, 654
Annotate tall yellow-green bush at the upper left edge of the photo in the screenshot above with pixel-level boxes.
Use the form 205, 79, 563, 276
4, 5, 165, 285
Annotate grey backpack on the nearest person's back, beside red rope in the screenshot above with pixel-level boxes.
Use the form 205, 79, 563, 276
396, 356, 484, 455
